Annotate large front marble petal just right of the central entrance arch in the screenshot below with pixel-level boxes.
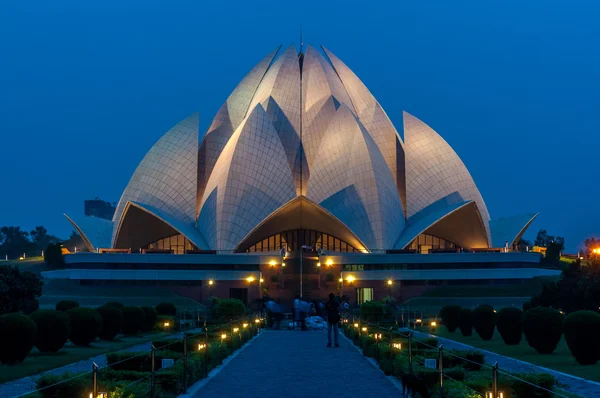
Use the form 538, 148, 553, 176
307, 105, 404, 251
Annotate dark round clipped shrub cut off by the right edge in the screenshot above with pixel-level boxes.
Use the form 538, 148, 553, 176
563, 311, 600, 365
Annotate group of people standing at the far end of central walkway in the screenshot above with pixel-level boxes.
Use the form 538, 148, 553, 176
263, 293, 350, 347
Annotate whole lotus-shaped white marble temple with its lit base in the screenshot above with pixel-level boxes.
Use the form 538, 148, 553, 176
45, 45, 554, 303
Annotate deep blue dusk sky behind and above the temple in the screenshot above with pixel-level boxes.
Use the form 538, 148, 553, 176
0, 0, 600, 251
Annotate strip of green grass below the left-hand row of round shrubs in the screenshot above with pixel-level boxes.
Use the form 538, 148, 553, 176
0, 333, 166, 383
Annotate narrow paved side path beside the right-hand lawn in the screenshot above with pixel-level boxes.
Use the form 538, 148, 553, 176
406, 330, 600, 398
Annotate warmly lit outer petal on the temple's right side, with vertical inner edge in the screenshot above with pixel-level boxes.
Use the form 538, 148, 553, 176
404, 112, 491, 245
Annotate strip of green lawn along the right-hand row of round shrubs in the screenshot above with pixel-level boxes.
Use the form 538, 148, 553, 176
426, 327, 600, 382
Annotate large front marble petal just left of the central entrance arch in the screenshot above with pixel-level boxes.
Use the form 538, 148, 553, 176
198, 104, 296, 250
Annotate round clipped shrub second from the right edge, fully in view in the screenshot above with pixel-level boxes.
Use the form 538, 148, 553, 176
523, 307, 564, 354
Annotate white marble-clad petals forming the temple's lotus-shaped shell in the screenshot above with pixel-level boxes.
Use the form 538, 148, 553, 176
69, 45, 531, 253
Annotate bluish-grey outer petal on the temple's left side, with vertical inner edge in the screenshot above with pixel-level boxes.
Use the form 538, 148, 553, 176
113, 113, 198, 246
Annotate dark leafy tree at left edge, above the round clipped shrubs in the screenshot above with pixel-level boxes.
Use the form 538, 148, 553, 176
0, 266, 44, 314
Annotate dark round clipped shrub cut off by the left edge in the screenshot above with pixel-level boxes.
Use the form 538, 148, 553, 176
0, 314, 37, 364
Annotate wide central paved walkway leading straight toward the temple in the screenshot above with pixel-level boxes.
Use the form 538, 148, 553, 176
194, 330, 400, 398
